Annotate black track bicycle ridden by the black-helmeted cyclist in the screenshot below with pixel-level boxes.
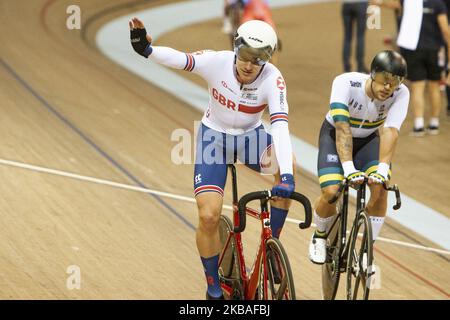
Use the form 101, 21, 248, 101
322, 177, 401, 300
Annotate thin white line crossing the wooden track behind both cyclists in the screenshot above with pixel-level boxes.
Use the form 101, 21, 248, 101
0, 159, 450, 255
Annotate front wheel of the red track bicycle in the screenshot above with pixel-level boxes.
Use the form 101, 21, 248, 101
266, 238, 296, 300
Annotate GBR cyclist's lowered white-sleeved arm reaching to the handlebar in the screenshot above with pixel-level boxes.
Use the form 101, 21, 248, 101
265, 74, 293, 174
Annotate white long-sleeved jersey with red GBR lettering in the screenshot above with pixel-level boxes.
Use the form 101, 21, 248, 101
149, 47, 293, 174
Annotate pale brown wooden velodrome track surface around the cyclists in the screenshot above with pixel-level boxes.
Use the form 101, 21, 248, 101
0, 0, 450, 299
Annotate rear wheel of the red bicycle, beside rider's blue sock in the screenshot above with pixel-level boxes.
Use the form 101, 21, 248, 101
219, 215, 244, 300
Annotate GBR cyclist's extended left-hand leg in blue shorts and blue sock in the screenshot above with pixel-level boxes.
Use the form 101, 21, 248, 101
194, 124, 227, 297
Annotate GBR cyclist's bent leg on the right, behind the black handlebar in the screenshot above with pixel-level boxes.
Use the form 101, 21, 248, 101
238, 125, 295, 238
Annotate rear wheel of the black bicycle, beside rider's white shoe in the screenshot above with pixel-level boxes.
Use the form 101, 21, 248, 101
322, 214, 342, 300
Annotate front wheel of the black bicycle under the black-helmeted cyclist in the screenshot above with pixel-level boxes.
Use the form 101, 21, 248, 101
347, 211, 374, 300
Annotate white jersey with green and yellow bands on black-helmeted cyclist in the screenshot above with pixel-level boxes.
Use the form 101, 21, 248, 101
326, 72, 409, 138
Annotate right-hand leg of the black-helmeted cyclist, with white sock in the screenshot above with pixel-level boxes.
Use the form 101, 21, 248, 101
354, 134, 387, 240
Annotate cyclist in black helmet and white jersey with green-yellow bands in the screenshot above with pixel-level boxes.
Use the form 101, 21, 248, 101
309, 50, 409, 264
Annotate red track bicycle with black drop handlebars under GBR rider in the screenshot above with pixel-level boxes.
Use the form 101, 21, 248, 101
219, 165, 312, 300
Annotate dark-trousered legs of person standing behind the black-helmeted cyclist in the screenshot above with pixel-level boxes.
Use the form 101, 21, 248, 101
342, 0, 368, 73
